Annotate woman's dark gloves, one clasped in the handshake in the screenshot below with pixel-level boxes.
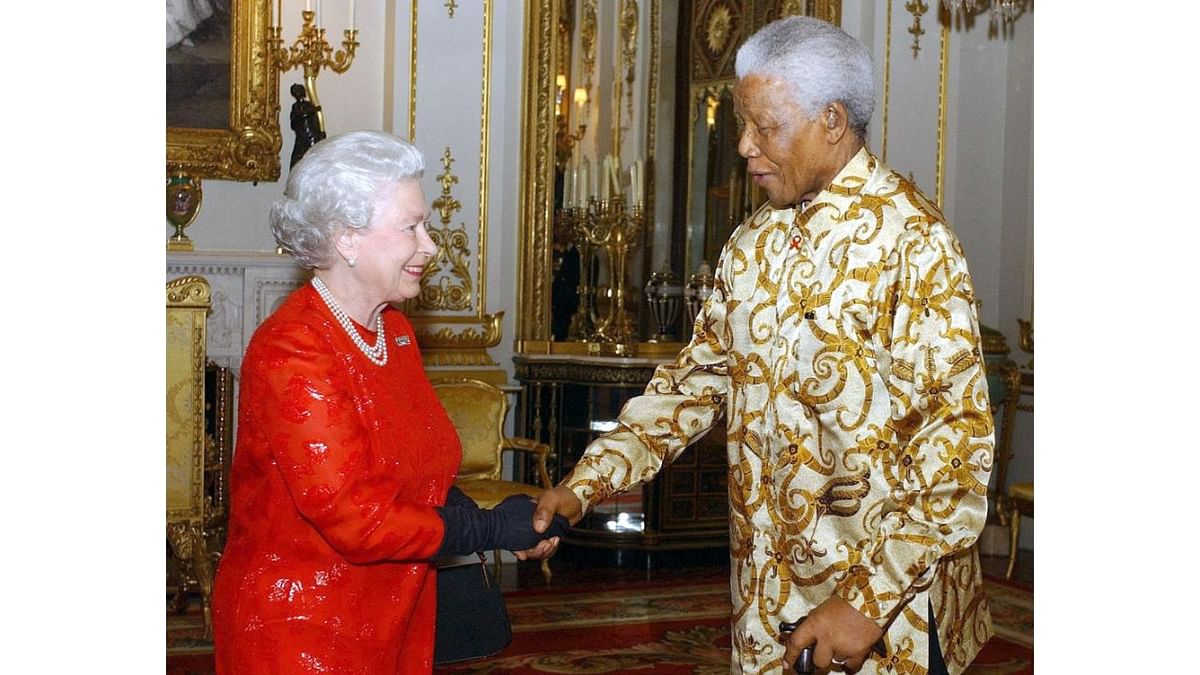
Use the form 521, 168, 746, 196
434, 495, 570, 557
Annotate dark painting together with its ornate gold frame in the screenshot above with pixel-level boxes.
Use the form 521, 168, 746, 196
166, 0, 282, 183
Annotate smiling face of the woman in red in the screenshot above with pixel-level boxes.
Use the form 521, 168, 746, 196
355, 180, 437, 303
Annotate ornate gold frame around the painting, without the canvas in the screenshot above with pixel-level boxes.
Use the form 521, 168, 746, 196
167, 0, 283, 183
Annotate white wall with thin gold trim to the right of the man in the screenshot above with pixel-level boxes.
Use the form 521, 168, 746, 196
842, 0, 1034, 549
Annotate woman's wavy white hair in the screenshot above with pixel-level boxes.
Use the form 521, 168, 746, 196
271, 131, 425, 269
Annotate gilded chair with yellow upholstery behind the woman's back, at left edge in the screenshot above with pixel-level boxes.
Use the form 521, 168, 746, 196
167, 276, 214, 634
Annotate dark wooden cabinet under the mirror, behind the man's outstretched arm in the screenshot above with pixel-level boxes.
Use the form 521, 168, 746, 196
514, 354, 728, 549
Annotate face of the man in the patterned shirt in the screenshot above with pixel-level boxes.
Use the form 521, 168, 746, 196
733, 74, 840, 209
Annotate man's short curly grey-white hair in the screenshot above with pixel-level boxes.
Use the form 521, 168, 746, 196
733, 17, 875, 137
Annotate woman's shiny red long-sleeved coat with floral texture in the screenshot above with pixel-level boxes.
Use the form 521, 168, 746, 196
212, 285, 462, 675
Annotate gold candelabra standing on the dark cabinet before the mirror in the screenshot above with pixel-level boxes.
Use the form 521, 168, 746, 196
563, 195, 644, 356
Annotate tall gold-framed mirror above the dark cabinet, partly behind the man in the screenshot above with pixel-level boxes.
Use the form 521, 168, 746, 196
517, 0, 841, 356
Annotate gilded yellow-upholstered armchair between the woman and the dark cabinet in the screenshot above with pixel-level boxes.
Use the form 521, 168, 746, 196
433, 378, 552, 583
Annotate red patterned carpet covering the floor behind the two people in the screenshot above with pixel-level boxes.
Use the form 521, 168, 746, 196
167, 571, 1033, 675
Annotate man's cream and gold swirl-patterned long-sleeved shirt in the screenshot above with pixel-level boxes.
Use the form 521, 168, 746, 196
564, 148, 992, 674
